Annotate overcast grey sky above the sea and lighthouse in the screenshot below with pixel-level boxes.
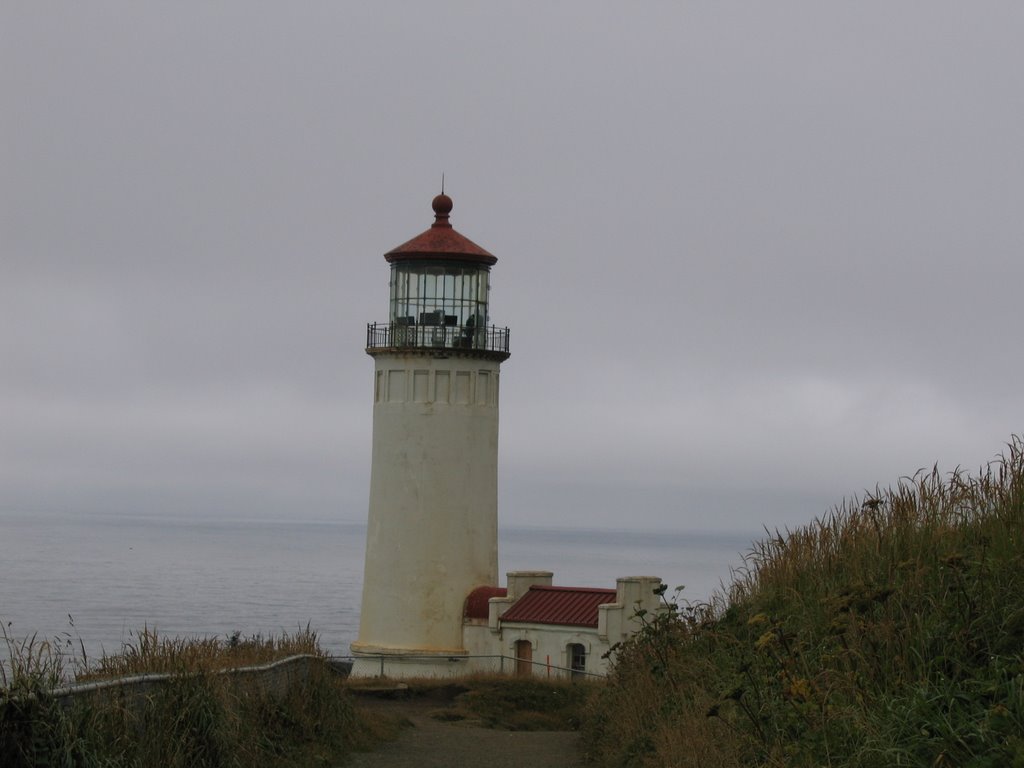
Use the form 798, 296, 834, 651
0, 0, 1024, 531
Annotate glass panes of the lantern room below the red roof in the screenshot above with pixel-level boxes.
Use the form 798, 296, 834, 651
390, 261, 490, 328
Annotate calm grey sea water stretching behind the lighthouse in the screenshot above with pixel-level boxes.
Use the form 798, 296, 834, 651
0, 513, 754, 656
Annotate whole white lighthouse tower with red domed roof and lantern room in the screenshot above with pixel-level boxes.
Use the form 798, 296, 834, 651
352, 194, 509, 677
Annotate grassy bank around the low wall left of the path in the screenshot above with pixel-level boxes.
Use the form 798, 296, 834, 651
0, 629, 376, 768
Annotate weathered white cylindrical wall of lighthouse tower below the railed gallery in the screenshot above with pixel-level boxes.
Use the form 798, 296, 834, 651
352, 354, 500, 676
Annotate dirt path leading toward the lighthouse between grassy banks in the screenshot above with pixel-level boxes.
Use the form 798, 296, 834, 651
345, 700, 583, 768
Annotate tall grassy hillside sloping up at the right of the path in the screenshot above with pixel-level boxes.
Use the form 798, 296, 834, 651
584, 438, 1024, 768
